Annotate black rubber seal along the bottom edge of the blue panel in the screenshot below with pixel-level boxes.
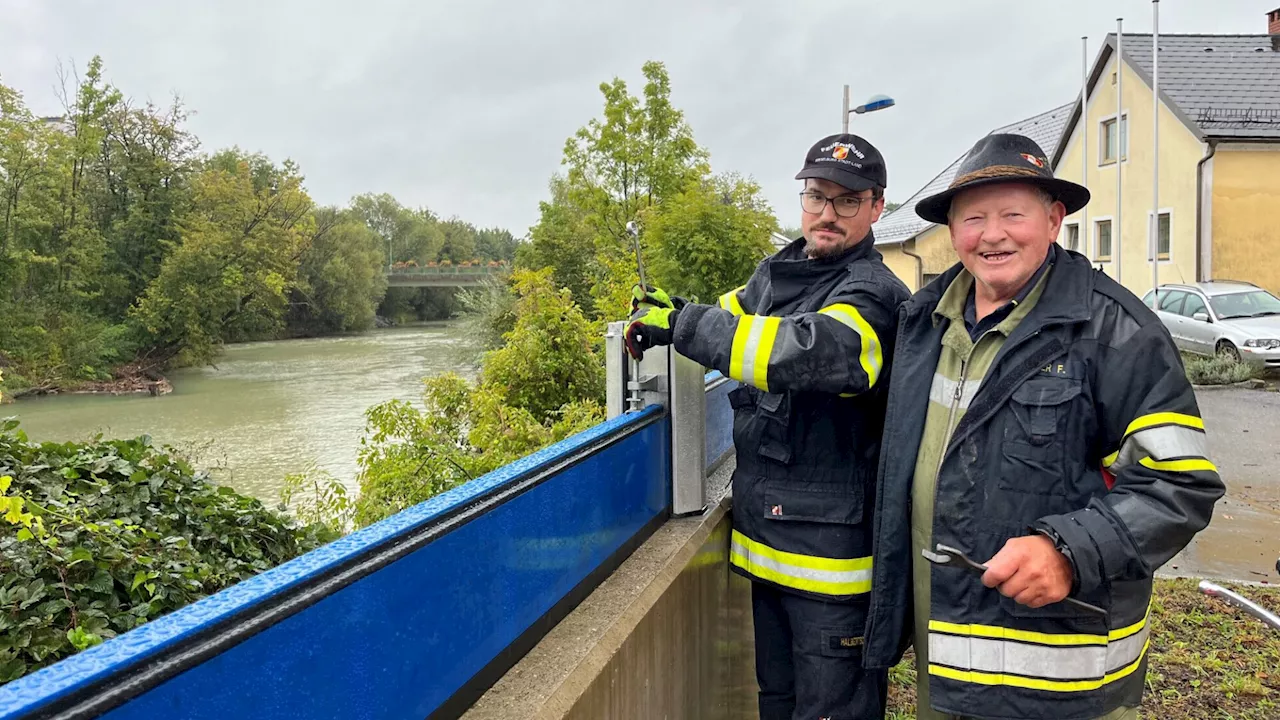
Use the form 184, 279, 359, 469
426, 511, 671, 720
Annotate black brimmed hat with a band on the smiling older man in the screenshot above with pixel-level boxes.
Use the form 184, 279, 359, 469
915, 135, 1089, 225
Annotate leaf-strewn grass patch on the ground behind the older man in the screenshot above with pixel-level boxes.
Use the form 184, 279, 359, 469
888, 579, 1280, 720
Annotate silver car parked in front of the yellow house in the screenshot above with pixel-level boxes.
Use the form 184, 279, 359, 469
1143, 281, 1280, 369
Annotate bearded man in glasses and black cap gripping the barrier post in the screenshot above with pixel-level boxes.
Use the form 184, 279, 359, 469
626, 135, 909, 720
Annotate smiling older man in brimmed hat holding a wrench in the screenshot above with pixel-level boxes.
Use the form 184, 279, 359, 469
865, 135, 1224, 720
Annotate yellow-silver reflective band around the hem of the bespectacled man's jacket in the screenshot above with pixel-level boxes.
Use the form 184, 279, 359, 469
730, 530, 872, 596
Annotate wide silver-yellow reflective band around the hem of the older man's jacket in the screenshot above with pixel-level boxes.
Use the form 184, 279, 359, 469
928, 619, 1151, 692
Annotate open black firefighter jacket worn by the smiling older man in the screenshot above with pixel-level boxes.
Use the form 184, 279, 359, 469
865, 245, 1224, 719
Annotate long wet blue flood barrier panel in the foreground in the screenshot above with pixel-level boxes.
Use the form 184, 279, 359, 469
0, 407, 671, 720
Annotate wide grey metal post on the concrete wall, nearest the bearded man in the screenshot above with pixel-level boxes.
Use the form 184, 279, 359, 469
667, 351, 707, 515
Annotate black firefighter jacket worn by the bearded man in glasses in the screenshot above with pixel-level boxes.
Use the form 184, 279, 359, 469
673, 233, 909, 601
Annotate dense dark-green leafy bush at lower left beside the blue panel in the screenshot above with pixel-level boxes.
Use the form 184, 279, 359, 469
0, 420, 328, 683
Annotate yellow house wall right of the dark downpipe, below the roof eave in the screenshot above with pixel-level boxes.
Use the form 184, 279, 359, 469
1211, 145, 1280, 293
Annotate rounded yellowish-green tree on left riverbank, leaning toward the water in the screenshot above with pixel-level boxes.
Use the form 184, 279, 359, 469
133, 150, 315, 363
